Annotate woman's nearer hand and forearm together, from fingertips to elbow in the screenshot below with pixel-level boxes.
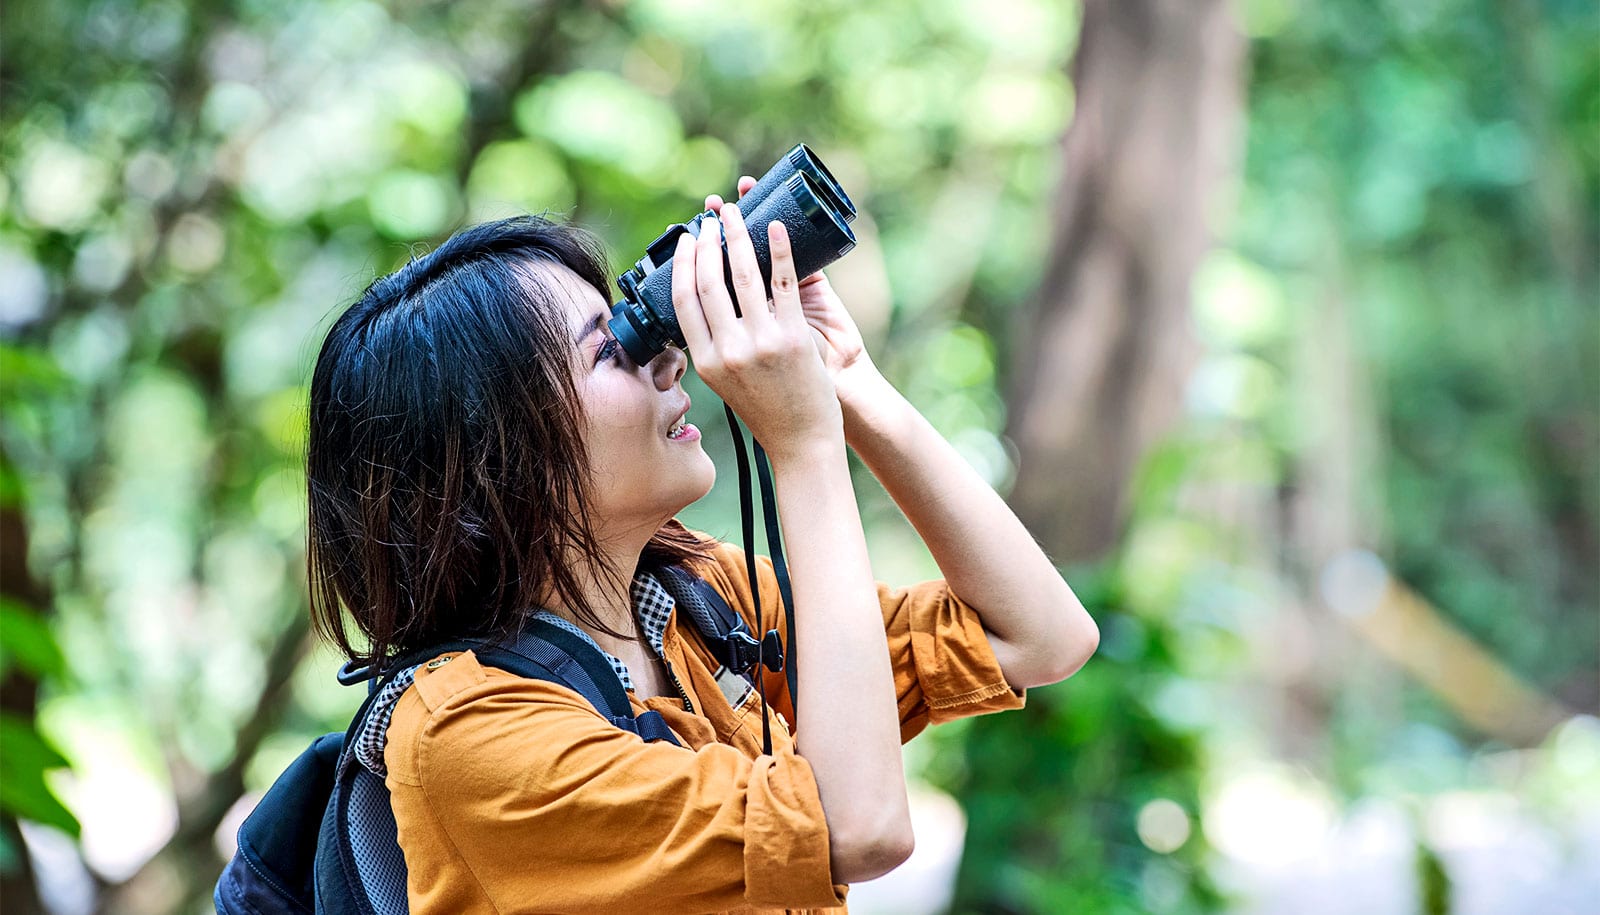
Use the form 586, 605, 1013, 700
672, 203, 914, 883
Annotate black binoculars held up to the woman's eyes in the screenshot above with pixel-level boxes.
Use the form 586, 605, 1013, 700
610, 142, 856, 365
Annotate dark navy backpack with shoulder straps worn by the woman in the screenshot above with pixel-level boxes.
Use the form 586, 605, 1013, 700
213, 566, 782, 915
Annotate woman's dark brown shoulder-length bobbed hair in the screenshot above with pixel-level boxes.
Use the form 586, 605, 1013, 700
306, 216, 707, 664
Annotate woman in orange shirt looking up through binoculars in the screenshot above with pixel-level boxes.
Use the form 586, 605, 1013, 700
300, 178, 1098, 912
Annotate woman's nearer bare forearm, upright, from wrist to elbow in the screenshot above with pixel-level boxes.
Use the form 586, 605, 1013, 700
773, 432, 910, 881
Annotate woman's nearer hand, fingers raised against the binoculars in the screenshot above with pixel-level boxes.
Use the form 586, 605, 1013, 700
672, 203, 843, 462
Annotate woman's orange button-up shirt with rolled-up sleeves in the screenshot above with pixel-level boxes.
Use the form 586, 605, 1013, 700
384, 544, 1022, 915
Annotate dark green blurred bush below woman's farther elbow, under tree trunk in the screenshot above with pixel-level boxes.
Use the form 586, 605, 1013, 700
928, 568, 1221, 915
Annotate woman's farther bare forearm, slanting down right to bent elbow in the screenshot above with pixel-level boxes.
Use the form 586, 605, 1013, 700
842, 371, 1099, 686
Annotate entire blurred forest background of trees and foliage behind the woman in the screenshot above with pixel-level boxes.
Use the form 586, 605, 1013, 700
0, 0, 1600, 915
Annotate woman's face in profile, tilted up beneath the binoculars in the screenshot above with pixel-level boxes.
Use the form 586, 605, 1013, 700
549, 267, 717, 539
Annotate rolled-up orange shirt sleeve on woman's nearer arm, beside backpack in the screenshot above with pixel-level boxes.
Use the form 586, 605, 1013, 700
386, 659, 843, 912
